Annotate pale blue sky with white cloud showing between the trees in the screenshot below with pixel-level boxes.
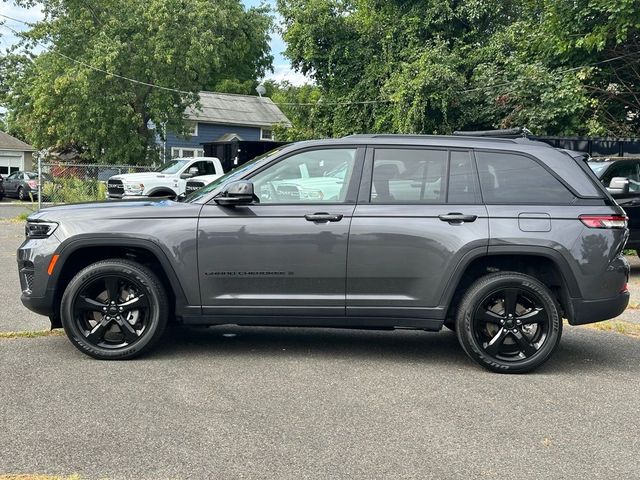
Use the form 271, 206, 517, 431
0, 0, 308, 85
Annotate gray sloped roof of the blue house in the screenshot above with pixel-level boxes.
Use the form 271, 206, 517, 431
186, 92, 291, 127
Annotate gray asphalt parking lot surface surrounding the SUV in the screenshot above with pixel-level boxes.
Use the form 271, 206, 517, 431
0, 221, 640, 480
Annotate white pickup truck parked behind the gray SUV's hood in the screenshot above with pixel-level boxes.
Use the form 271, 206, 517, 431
107, 157, 224, 199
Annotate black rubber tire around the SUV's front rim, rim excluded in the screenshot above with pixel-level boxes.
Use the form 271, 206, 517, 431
61, 261, 167, 360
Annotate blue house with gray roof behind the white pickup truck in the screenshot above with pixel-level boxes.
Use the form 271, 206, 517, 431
163, 92, 291, 160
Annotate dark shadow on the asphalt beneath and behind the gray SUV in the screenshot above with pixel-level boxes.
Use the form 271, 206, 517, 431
144, 325, 640, 375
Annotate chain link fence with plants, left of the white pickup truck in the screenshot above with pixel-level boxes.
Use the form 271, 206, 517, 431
35, 162, 153, 205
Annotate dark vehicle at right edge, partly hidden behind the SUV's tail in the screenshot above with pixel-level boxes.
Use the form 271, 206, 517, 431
588, 157, 640, 255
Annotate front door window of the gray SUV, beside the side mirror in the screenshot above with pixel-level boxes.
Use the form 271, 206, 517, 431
251, 148, 356, 204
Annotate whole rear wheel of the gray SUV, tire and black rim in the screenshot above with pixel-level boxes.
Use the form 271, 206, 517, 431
456, 272, 562, 373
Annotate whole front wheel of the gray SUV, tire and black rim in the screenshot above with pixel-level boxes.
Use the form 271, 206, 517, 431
60, 259, 169, 360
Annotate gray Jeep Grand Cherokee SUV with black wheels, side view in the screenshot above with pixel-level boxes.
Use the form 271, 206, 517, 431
18, 135, 629, 372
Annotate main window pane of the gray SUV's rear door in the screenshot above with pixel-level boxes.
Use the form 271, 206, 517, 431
371, 148, 447, 203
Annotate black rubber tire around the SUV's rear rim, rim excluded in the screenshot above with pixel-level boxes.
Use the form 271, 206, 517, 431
456, 273, 562, 373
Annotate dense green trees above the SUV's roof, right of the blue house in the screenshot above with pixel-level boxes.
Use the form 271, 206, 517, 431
278, 0, 640, 137
